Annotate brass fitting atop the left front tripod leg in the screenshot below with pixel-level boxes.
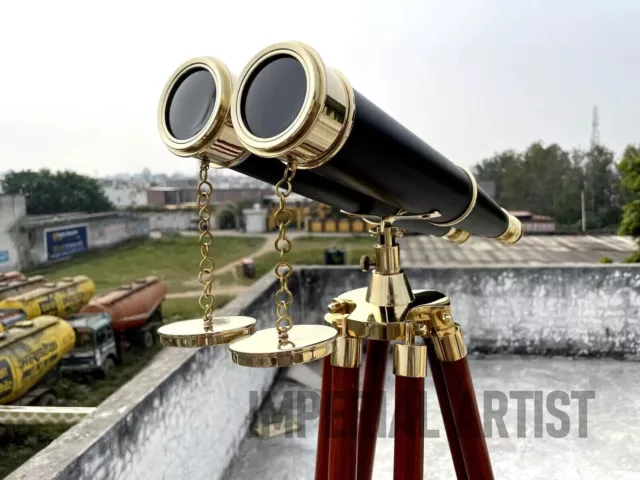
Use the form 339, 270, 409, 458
329, 298, 362, 368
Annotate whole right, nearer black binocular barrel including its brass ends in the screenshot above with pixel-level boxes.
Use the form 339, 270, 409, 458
231, 42, 522, 243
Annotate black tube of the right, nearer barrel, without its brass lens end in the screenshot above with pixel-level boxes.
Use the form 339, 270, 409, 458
313, 91, 509, 237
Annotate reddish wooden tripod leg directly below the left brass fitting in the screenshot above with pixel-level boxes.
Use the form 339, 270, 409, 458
329, 366, 360, 480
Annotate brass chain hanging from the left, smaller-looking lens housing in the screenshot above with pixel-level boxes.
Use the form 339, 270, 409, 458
197, 160, 215, 332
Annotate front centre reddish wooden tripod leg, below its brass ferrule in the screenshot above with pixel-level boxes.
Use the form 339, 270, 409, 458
393, 375, 424, 480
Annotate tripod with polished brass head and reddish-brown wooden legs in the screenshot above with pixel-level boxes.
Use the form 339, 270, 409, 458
315, 219, 494, 480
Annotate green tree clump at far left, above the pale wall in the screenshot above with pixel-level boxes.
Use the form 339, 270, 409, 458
2, 169, 114, 215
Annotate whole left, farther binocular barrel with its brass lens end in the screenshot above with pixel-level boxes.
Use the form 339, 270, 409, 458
158, 57, 451, 236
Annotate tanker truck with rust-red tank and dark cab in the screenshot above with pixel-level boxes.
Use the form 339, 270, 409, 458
62, 276, 167, 376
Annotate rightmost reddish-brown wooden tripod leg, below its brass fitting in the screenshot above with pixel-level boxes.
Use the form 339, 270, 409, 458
441, 356, 494, 480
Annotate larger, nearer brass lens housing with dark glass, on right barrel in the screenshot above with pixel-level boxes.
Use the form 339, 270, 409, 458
231, 42, 355, 169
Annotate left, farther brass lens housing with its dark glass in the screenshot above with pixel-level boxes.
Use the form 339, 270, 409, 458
158, 57, 249, 167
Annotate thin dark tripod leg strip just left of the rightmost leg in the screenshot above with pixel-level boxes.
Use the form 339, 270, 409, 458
427, 340, 469, 480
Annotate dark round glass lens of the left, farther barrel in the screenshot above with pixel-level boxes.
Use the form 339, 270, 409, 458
165, 68, 216, 140
